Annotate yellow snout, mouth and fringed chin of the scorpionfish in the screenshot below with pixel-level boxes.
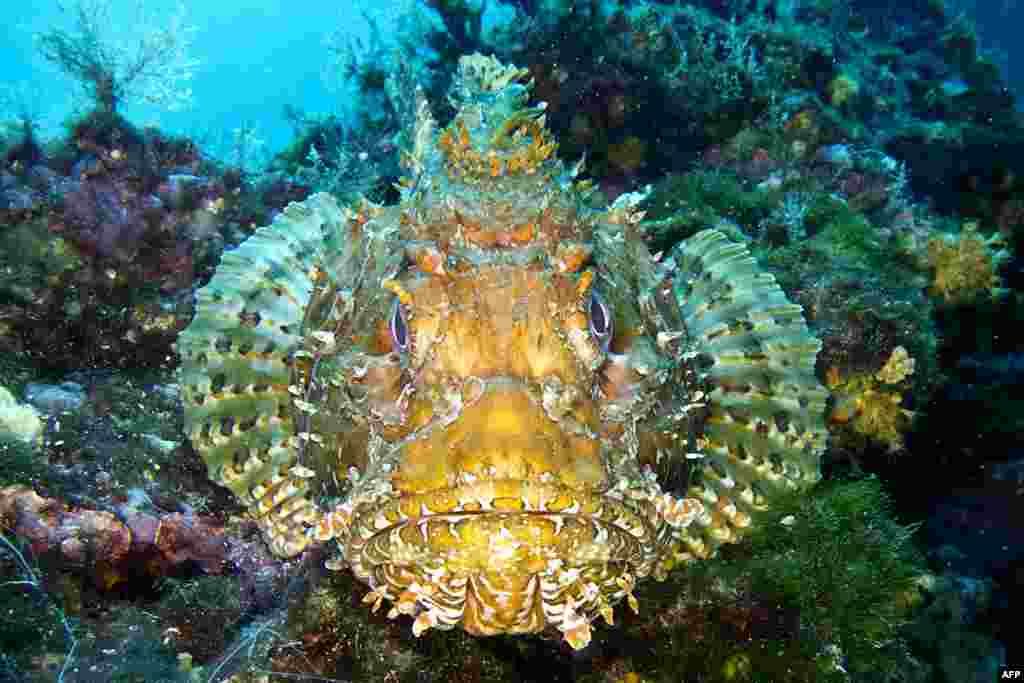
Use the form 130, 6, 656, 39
331, 378, 660, 644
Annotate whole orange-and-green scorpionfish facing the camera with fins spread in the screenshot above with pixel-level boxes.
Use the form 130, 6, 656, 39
177, 54, 827, 648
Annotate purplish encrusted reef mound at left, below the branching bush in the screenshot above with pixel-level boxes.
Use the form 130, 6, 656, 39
0, 108, 308, 369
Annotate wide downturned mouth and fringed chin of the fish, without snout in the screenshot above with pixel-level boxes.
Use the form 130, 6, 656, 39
347, 479, 656, 635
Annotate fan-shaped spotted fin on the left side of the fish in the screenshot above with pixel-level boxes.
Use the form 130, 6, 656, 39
177, 194, 401, 556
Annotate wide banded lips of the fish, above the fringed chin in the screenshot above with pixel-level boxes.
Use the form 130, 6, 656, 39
345, 480, 656, 578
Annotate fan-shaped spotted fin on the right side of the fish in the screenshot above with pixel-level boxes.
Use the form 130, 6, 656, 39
663, 230, 828, 559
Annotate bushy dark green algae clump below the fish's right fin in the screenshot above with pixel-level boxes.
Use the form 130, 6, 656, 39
745, 479, 924, 680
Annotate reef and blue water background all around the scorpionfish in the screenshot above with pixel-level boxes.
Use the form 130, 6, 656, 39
0, 0, 1024, 683
